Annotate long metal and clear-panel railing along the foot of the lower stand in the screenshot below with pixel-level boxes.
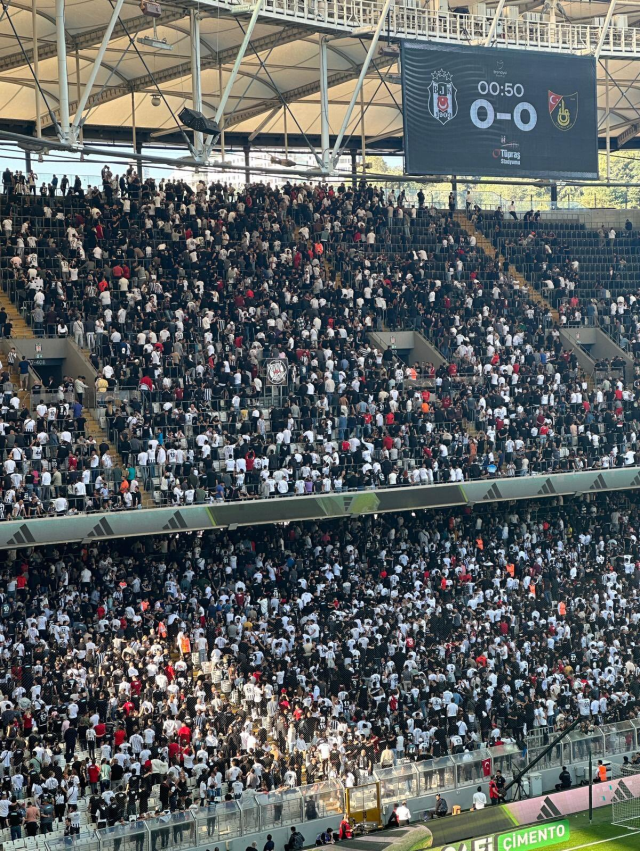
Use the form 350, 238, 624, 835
27, 720, 640, 851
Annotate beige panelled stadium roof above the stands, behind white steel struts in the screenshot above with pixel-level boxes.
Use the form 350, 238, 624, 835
0, 0, 640, 155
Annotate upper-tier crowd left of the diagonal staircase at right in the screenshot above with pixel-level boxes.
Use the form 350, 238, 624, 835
0, 172, 640, 518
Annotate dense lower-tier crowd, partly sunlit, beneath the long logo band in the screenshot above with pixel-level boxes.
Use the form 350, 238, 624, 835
0, 494, 640, 836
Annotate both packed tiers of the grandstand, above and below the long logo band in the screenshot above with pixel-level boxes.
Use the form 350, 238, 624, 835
0, 167, 640, 851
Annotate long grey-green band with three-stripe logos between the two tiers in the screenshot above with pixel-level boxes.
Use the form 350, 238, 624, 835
0, 467, 640, 549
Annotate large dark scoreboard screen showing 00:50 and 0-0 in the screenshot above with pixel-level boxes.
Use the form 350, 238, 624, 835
401, 41, 598, 178
